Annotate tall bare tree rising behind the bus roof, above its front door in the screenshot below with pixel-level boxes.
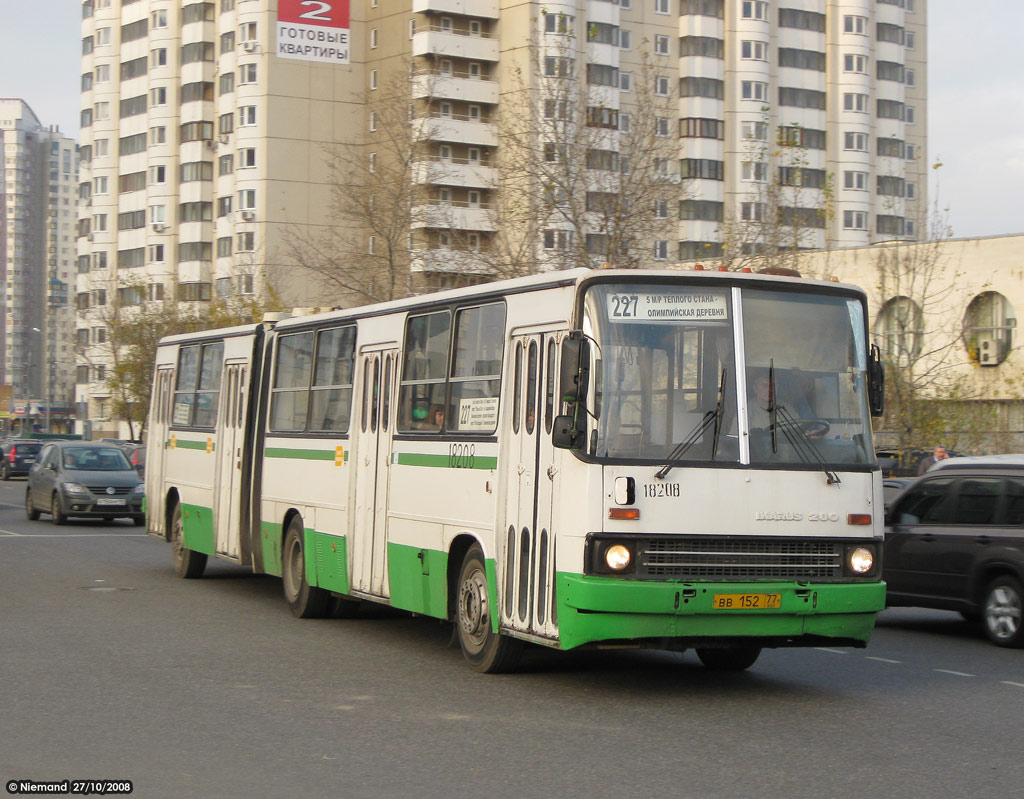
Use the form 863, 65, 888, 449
485, 29, 680, 276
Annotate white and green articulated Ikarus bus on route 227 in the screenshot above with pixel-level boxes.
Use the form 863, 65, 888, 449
145, 269, 885, 672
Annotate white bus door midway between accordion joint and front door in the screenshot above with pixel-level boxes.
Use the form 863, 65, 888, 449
348, 345, 398, 596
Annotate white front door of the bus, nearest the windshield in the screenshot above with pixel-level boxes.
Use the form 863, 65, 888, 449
499, 332, 558, 637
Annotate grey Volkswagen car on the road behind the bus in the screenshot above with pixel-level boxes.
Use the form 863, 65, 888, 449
25, 441, 145, 525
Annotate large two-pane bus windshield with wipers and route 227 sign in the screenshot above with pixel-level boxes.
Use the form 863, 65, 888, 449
584, 284, 872, 468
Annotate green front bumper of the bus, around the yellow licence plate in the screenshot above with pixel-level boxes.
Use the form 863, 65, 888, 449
556, 573, 886, 649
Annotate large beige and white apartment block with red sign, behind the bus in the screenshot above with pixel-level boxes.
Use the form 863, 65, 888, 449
77, 0, 927, 432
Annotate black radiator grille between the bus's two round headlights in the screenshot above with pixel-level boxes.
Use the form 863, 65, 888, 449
637, 538, 843, 580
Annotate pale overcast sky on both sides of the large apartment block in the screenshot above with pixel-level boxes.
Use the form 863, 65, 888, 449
0, 0, 1024, 237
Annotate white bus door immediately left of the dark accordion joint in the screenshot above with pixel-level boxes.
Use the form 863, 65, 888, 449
214, 362, 247, 558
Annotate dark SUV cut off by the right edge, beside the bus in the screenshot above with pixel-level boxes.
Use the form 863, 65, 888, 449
882, 455, 1024, 646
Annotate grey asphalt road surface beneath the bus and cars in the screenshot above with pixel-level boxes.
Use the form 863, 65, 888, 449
0, 480, 1024, 799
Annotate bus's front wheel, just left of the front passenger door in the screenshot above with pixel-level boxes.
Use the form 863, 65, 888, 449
455, 544, 523, 674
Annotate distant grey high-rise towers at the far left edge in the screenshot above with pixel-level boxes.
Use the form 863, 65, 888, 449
0, 98, 78, 430
